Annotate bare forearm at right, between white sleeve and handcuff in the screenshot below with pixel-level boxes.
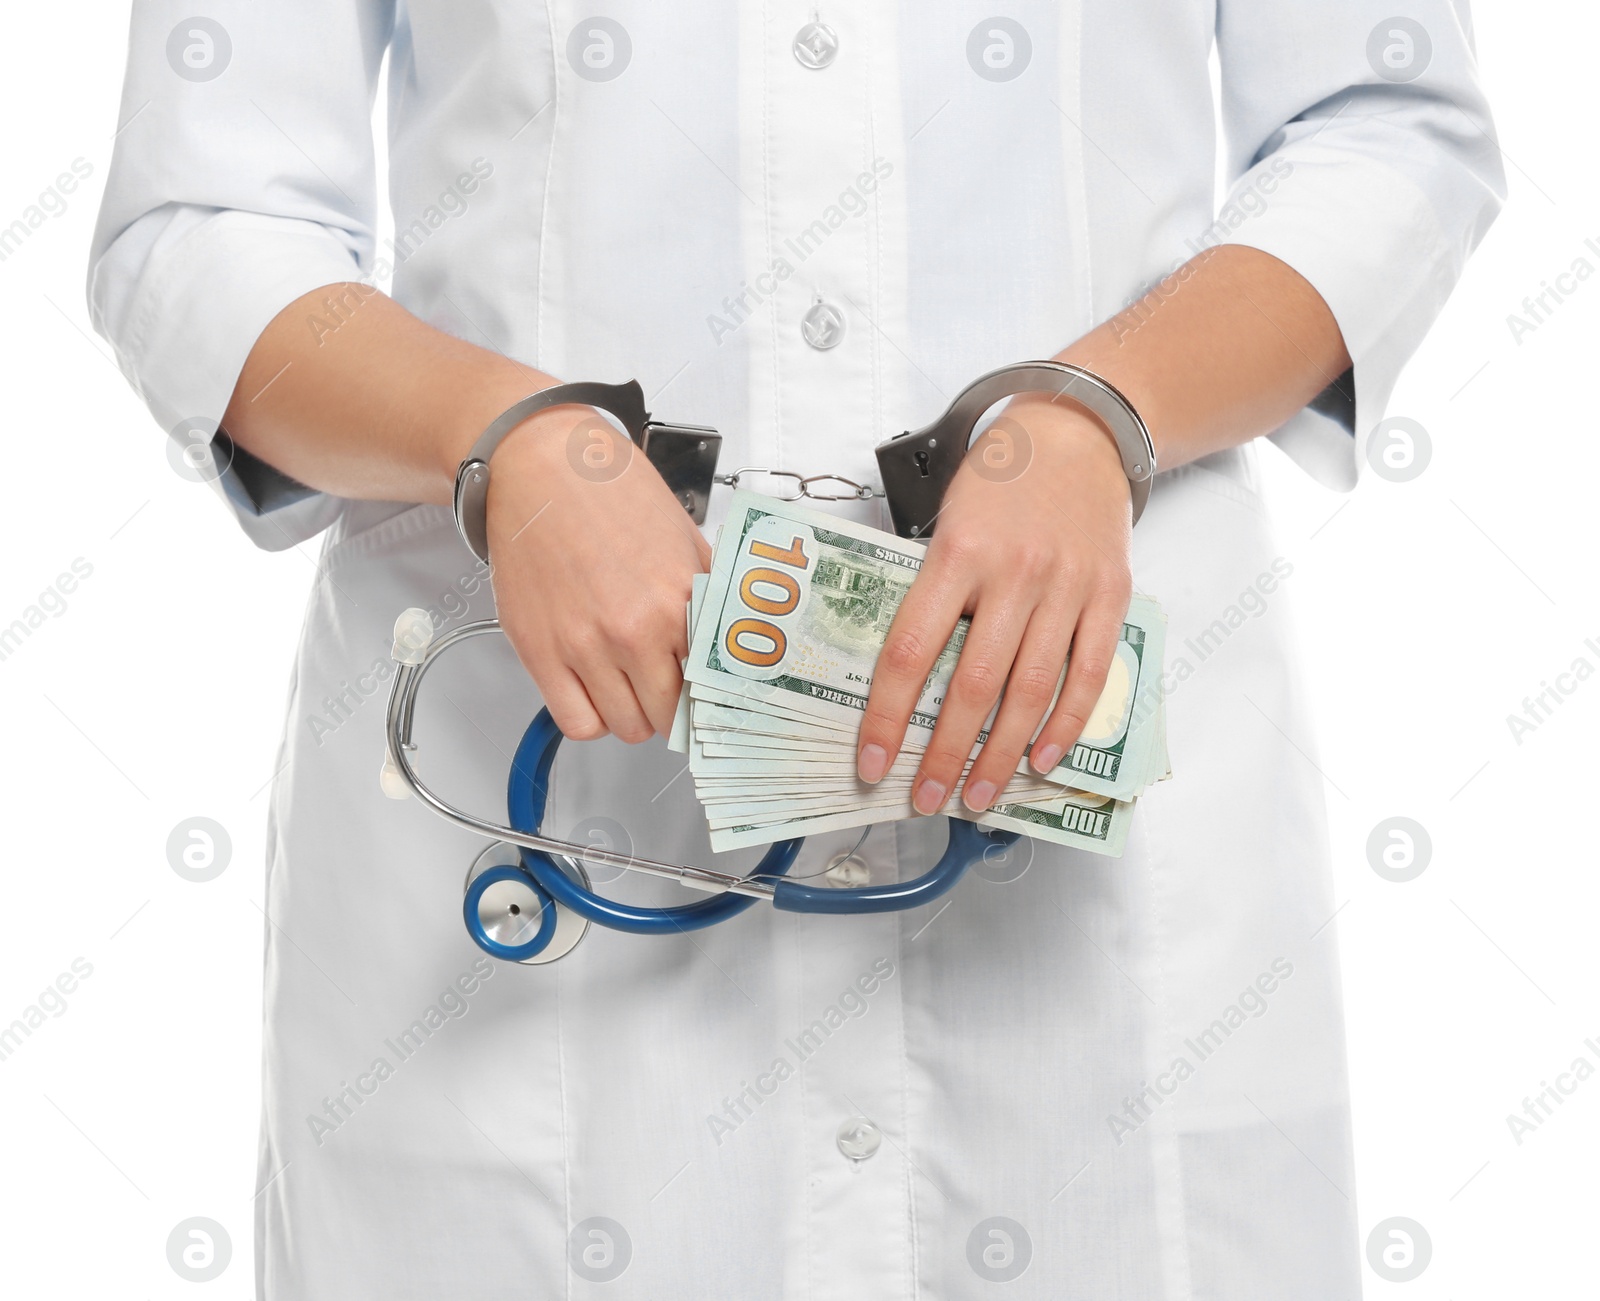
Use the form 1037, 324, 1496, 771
1056, 245, 1350, 469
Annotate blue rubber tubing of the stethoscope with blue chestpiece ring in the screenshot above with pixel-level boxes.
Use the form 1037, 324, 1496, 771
462, 709, 1018, 962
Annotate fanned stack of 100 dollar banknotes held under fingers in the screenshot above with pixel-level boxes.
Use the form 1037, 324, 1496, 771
669, 491, 1171, 856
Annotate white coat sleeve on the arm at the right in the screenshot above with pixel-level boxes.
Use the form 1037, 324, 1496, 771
1206, 0, 1506, 490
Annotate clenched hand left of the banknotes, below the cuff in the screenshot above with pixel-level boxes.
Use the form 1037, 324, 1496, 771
488, 406, 710, 744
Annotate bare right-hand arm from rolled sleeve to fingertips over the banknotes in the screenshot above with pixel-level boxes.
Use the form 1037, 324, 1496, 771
876, 246, 1350, 796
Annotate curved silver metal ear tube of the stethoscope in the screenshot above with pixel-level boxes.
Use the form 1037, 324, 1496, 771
386, 619, 773, 899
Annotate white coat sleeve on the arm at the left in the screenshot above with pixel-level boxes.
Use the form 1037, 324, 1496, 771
88, 0, 392, 550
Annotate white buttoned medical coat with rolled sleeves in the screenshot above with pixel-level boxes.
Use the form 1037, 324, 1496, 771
90, 0, 1501, 1301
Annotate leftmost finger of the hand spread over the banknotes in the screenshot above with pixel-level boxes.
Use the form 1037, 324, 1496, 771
856, 566, 966, 783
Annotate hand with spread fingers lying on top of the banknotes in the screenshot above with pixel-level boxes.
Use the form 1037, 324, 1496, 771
856, 395, 1133, 813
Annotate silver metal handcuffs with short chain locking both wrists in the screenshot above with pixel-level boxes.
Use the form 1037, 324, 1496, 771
454, 362, 1155, 562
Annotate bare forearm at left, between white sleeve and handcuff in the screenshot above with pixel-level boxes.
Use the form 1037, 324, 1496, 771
222, 285, 555, 504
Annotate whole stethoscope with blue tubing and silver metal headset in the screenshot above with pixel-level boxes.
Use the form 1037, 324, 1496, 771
382, 610, 1018, 965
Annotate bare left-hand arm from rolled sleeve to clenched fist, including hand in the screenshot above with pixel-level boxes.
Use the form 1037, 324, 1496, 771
224, 283, 710, 741
